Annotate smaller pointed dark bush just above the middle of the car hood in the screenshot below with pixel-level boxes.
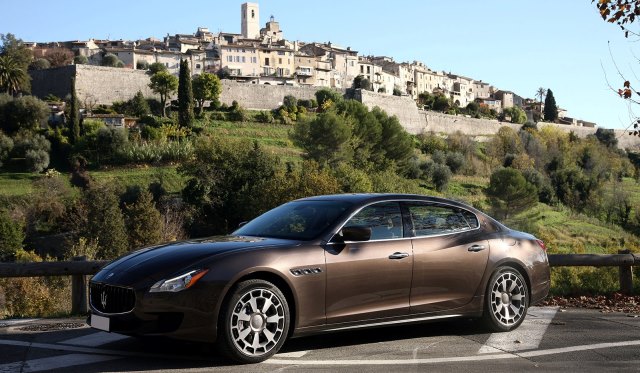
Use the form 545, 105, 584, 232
125, 190, 163, 249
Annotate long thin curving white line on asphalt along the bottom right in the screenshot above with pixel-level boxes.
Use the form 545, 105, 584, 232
262, 340, 640, 366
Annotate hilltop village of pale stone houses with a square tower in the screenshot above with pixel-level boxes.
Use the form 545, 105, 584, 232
22, 3, 596, 127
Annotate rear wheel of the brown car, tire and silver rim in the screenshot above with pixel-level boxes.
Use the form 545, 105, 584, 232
482, 266, 529, 332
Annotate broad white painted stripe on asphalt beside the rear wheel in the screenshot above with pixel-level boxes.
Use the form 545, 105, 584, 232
478, 307, 559, 354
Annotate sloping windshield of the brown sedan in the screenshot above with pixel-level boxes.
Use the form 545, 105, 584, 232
233, 201, 352, 240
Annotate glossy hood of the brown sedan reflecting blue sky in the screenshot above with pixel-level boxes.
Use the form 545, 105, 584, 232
92, 236, 295, 286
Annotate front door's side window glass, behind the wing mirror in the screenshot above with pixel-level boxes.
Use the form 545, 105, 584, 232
345, 202, 403, 240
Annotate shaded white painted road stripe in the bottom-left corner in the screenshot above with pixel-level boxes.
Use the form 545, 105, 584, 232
0, 354, 122, 373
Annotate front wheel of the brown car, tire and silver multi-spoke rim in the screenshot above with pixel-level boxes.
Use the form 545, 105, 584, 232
218, 280, 291, 364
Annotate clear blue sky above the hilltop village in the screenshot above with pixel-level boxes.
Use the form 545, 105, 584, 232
0, 0, 640, 128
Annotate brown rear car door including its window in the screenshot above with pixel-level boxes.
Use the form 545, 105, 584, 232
405, 202, 489, 313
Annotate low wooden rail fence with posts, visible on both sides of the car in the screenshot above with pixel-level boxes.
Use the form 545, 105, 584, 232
0, 250, 640, 314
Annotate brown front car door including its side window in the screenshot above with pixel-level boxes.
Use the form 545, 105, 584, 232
325, 202, 413, 324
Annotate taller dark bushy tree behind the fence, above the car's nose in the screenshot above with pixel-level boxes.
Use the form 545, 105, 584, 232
82, 185, 129, 259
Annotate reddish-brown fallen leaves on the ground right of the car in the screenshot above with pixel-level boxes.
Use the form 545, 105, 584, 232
540, 293, 640, 316
